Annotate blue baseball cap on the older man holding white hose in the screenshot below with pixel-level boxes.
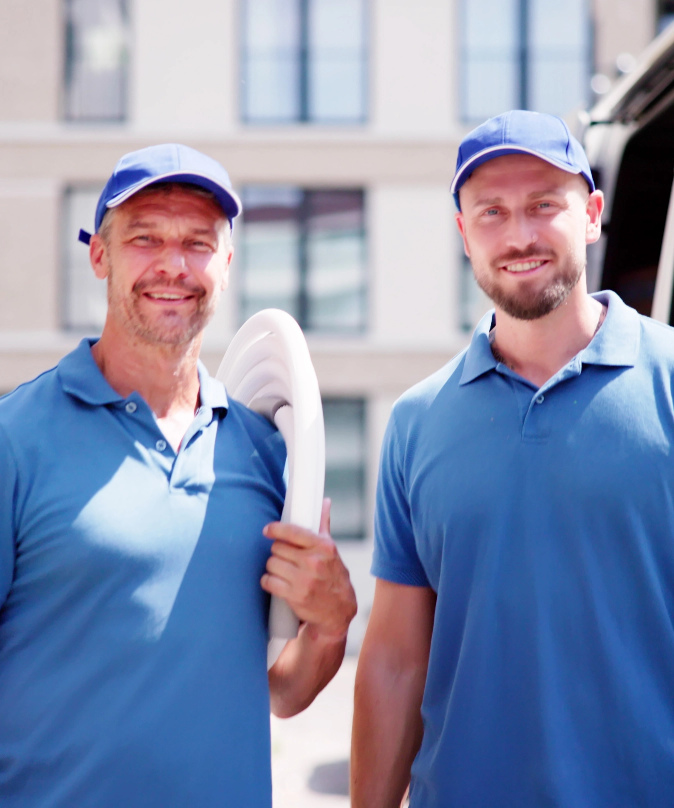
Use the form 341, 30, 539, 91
79, 143, 241, 244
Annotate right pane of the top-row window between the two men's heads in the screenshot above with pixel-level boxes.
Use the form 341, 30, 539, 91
307, 0, 365, 121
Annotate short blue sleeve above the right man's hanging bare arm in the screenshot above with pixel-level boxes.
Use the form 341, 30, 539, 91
372, 410, 429, 586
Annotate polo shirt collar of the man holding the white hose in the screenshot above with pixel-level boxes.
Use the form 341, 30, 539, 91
57, 338, 228, 410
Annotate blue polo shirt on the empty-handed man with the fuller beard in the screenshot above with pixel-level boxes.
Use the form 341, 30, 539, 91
373, 293, 674, 808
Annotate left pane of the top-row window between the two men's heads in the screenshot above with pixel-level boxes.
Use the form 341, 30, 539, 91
242, 0, 301, 122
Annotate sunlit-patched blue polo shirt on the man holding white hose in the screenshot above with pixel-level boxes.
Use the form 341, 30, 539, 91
0, 341, 285, 808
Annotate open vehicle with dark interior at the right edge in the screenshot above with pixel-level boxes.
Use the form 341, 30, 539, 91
582, 25, 674, 324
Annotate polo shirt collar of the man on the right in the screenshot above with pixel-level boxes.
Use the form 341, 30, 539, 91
459, 291, 640, 385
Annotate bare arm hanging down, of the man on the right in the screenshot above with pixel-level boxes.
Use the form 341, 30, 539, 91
351, 579, 435, 808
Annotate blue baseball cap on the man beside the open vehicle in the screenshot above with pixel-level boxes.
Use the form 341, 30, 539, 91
451, 109, 595, 210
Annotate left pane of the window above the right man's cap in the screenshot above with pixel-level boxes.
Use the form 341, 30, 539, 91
462, 0, 519, 121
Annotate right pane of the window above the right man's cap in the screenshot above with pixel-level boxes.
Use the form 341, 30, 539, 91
528, 0, 590, 115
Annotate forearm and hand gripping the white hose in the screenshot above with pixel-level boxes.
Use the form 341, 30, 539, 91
260, 500, 357, 718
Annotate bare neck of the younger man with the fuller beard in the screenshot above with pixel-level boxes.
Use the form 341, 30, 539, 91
486, 290, 604, 387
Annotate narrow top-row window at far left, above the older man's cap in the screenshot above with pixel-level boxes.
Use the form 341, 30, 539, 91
63, 0, 129, 121
